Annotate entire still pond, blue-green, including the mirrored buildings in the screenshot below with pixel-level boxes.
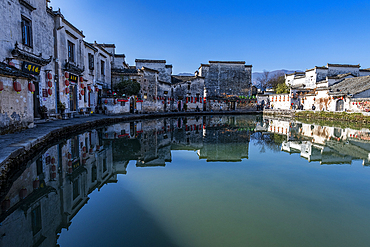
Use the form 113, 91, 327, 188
0, 116, 370, 247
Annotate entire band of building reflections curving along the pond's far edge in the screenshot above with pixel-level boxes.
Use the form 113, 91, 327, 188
0, 116, 370, 246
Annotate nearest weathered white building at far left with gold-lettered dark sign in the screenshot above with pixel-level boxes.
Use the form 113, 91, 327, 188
0, 0, 56, 129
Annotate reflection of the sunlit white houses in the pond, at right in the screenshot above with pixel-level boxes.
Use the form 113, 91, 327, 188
261, 118, 370, 166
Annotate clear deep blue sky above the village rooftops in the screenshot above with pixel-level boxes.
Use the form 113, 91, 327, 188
51, 0, 370, 74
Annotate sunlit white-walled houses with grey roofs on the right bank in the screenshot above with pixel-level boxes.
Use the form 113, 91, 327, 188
269, 64, 370, 112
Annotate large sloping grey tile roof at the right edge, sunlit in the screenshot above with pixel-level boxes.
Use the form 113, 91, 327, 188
329, 76, 370, 95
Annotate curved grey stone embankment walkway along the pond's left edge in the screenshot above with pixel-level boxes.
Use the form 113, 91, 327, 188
0, 111, 261, 177
